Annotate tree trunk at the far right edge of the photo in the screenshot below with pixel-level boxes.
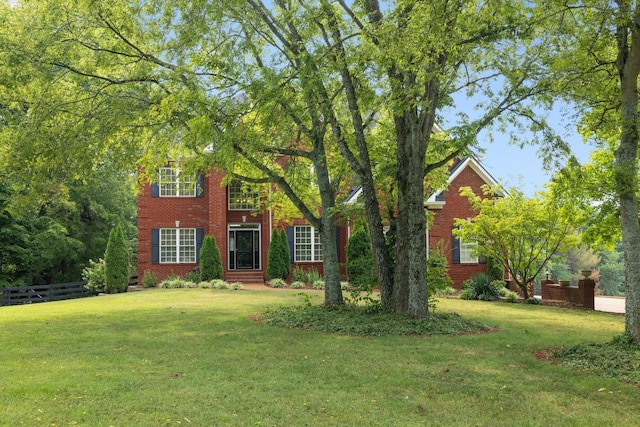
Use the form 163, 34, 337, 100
615, 1, 640, 342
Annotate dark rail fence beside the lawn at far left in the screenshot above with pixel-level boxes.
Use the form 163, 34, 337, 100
0, 282, 97, 306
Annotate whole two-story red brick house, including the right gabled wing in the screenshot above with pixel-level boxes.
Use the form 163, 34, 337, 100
138, 157, 496, 288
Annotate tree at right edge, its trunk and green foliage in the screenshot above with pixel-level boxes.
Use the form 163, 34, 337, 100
540, 0, 640, 341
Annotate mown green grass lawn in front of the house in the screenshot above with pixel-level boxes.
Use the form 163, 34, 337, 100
0, 289, 640, 426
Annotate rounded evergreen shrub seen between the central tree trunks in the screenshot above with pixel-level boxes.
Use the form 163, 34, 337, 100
347, 227, 376, 290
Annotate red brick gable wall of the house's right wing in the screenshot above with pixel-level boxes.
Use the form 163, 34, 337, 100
429, 167, 487, 289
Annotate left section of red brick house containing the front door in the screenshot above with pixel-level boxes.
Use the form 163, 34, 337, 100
138, 167, 348, 283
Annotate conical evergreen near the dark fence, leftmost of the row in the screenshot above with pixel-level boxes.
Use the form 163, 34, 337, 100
104, 225, 129, 294
